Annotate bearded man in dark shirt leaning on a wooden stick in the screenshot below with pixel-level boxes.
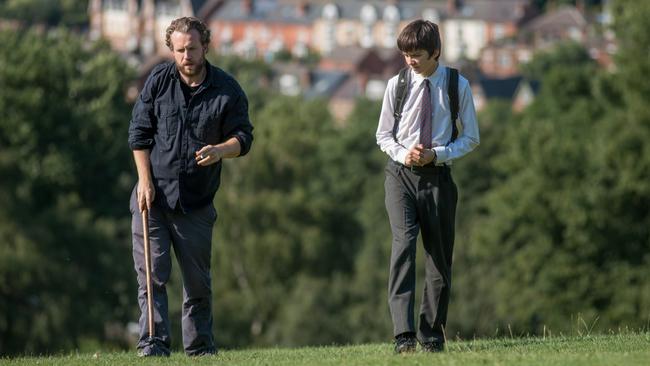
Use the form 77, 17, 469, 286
129, 17, 253, 356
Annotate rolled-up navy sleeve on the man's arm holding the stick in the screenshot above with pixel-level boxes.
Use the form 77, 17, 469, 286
129, 71, 157, 150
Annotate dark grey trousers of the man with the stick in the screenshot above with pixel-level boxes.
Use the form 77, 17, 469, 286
130, 193, 217, 355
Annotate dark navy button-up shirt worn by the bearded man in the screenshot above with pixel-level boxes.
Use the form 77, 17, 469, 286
129, 61, 253, 212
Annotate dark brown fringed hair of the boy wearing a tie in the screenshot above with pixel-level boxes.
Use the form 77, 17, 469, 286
397, 19, 442, 61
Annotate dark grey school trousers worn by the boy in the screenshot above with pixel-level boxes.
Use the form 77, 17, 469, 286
385, 159, 458, 342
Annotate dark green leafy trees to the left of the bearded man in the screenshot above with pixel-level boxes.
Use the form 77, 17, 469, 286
0, 29, 136, 354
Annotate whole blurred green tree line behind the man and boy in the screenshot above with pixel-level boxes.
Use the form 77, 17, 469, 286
0, 0, 650, 355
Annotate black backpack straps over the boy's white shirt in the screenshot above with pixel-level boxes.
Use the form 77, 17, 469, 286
393, 67, 459, 143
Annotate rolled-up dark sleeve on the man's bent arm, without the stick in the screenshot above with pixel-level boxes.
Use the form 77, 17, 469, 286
223, 89, 253, 156
